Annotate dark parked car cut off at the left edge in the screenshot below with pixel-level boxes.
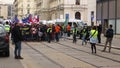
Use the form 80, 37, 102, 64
0, 24, 10, 57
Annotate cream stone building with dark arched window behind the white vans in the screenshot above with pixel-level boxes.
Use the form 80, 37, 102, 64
37, 0, 88, 22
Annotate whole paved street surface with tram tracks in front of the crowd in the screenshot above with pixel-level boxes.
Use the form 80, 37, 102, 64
0, 35, 120, 68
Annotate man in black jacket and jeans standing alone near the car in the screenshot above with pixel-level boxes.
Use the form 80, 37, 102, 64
12, 23, 23, 59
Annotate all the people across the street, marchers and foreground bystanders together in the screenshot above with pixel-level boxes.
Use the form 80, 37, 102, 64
2, 22, 113, 59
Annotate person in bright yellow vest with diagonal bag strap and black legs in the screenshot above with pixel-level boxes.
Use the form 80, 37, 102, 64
90, 26, 98, 54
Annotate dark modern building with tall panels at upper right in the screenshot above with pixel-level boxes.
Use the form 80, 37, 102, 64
96, 0, 120, 34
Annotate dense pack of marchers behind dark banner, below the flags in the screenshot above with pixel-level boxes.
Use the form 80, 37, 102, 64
10, 24, 70, 43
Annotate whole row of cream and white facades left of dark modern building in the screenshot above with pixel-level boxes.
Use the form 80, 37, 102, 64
14, 0, 96, 25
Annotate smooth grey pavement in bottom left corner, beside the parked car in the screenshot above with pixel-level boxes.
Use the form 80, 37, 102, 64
0, 47, 24, 68
